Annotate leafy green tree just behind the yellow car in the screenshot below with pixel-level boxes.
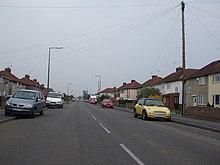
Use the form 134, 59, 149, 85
137, 87, 161, 99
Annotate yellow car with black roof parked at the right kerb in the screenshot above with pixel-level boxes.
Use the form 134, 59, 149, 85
133, 98, 171, 121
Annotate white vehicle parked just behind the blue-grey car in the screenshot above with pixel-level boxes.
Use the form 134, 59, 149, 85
46, 92, 64, 108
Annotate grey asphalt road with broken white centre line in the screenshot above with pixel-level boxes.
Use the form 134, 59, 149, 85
0, 103, 220, 165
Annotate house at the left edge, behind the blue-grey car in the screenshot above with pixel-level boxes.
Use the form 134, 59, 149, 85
0, 68, 26, 96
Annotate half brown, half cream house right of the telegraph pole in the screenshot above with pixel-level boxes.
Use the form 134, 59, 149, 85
185, 60, 220, 108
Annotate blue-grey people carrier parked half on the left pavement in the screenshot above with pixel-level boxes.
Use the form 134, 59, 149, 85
5, 89, 46, 118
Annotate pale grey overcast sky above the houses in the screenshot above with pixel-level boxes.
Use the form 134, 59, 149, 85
0, 0, 220, 96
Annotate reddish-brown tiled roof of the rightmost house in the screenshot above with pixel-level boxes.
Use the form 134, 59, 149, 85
189, 60, 220, 79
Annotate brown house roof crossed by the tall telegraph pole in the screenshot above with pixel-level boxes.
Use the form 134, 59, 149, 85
161, 68, 198, 83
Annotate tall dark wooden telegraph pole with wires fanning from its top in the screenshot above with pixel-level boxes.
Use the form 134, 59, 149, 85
181, 1, 186, 116
